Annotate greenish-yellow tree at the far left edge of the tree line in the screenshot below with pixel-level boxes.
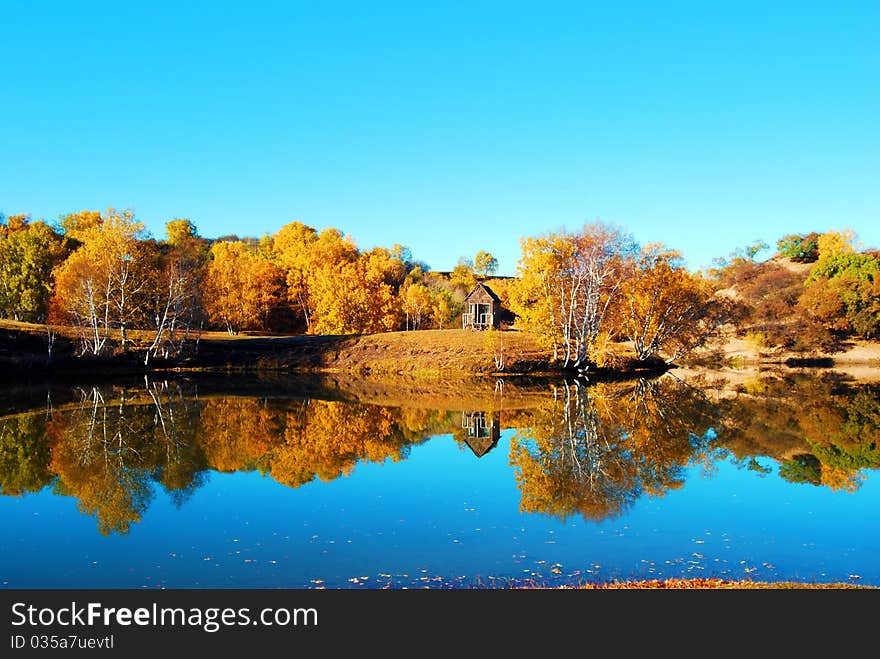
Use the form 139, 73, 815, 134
0, 215, 69, 322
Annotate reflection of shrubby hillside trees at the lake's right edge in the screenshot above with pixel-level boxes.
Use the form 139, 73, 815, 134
719, 374, 880, 492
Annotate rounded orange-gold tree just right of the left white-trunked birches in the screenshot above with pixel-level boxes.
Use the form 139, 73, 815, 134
203, 241, 284, 334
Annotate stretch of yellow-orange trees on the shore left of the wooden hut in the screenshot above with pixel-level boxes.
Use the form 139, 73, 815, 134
0, 208, 498, 360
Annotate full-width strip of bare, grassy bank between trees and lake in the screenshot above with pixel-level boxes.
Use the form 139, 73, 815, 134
0, 321, 880, 382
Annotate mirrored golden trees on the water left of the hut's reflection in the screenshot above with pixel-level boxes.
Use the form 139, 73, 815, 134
0, 382, 454, 533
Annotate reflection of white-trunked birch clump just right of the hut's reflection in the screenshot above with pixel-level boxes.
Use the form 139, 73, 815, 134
510, 376, 718, 520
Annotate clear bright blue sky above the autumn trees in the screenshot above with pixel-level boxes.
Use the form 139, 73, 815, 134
0, 0, 880, 274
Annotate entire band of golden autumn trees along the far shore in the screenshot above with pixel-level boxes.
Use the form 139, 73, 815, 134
0, 208, 880, 369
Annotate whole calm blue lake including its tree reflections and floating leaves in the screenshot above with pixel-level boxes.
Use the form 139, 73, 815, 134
0, 374, 880, 588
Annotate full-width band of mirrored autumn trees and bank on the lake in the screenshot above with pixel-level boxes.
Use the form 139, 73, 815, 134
0, 375, 880, 534
